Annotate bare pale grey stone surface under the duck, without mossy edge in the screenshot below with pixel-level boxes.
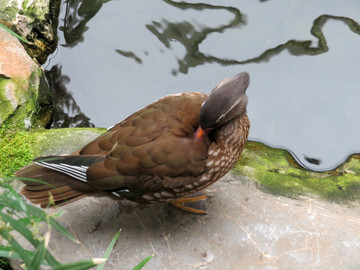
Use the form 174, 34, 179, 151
43, 174, 360, 270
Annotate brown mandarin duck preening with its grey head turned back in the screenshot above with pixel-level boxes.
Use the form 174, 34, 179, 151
15, 72, 250, 214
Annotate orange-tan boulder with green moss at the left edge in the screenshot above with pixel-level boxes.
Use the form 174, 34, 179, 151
0, 28, 50, 127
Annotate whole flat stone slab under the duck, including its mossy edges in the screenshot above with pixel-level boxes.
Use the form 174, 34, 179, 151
5, 128, 360, 270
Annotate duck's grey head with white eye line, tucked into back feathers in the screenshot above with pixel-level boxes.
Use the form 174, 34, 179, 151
200, 72, 250, 130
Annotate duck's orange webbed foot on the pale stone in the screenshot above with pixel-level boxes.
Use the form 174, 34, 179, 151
171, 194, 212, 215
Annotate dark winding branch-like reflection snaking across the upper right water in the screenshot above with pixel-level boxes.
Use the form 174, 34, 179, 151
146, 10, 360, 75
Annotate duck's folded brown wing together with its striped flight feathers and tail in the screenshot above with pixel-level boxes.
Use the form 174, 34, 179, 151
16, 93, 207, 206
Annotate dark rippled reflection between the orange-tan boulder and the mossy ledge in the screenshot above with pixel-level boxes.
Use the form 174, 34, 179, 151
45, 65, 94, 128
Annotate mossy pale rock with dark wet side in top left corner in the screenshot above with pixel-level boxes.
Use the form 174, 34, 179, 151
0, 0, 61, 63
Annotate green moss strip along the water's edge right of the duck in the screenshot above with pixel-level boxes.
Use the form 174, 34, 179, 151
234, 142, 360, 202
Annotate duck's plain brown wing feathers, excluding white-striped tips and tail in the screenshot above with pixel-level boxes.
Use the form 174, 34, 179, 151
80, 93, 209, 196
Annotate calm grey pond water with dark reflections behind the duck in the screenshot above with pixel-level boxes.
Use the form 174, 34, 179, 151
44, 0, 360, 170
